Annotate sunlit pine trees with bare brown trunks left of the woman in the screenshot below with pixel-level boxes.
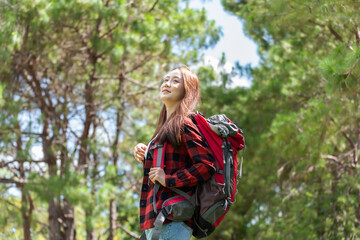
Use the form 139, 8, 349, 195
0, 0, 220, 239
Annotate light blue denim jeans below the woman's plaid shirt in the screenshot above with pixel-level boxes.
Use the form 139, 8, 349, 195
145, 222, 192, 240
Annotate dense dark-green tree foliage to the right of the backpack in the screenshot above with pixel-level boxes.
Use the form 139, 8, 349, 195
217, 0, 360, 239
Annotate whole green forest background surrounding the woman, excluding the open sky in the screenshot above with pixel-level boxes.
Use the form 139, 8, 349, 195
0, 0, 360, 240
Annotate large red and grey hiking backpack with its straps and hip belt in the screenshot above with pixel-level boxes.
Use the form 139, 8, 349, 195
152, 112, 245, 239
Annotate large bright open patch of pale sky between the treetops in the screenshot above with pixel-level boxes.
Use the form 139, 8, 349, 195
189, 0, 259, 87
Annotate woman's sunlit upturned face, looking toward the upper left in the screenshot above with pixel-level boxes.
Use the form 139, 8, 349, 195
160, 69, 185, 105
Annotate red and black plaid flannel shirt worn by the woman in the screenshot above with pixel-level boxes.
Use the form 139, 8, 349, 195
140, 117, 216, 231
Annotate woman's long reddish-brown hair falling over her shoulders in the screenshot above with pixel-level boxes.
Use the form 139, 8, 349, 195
153, 67, 200, 146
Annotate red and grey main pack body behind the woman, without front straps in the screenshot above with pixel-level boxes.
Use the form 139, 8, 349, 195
193, 114, 245, 238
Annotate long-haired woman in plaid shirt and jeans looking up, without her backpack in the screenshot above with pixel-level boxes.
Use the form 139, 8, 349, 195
134, 67, 215, 240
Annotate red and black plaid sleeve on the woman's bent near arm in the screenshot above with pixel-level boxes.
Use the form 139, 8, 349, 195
165, 120, 216, 188
